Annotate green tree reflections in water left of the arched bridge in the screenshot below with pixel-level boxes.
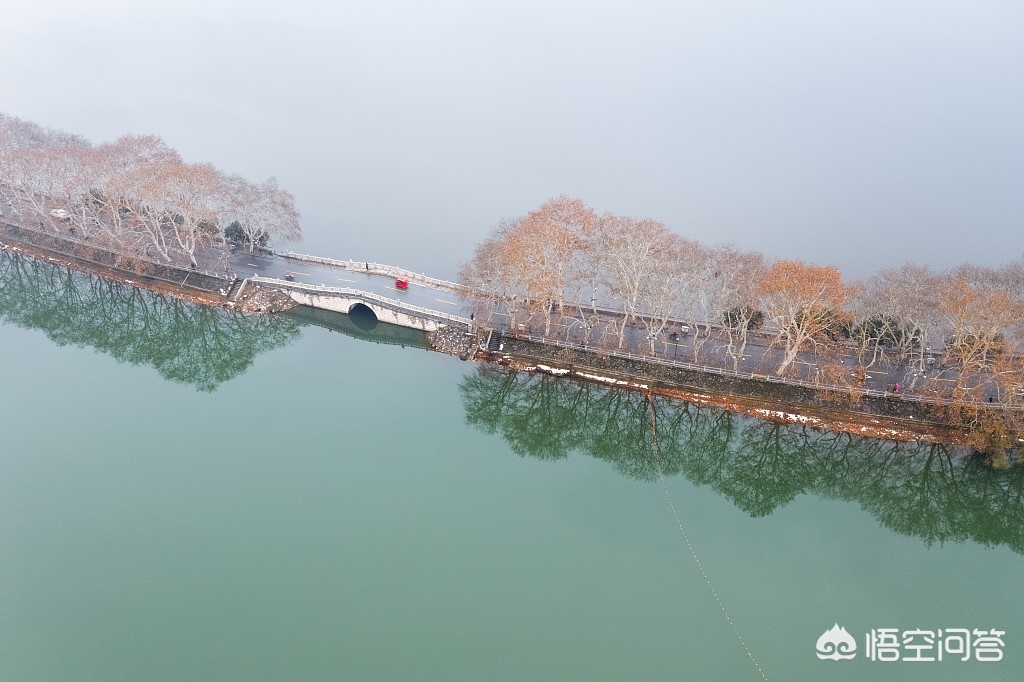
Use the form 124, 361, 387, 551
0, 252, 300, 391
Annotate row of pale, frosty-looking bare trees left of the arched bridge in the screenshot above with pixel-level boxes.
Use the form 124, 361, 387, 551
0, 114, 301, 267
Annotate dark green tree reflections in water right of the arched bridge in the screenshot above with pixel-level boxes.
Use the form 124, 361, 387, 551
459, 366, 1024, 554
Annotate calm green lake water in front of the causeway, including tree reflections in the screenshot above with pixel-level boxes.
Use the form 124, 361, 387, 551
0, 250, 1024, 680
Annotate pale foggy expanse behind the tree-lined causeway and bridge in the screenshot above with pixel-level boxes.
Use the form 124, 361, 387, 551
0, 0, 1024, 278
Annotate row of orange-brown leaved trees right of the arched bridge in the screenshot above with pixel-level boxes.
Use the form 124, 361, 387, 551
460, 197, 1024, 400
